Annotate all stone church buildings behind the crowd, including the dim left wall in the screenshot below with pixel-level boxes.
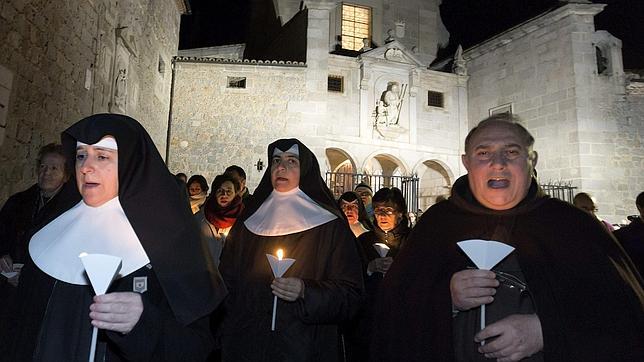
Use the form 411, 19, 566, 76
0, 0, 644, 222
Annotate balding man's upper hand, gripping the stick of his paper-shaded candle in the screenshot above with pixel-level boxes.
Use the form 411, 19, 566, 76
449, 269, 499, 311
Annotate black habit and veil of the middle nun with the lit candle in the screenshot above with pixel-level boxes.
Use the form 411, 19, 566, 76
219, 139, 363, 362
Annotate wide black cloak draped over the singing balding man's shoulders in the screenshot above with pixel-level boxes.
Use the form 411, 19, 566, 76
371, 176, 644, 361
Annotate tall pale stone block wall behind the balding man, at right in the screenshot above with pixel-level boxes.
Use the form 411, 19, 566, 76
464, 4, 644, 222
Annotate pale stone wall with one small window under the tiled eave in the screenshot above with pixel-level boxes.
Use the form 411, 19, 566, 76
168, 61, 316, 189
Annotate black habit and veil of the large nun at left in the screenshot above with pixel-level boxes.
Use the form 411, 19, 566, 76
0, 114, 226, 361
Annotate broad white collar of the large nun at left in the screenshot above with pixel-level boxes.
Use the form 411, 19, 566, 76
29, 197, 150, 285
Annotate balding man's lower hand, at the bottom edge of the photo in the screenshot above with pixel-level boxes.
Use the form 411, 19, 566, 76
474, 314, 543, 362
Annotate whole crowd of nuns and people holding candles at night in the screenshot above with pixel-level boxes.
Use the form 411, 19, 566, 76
0, 114, 644, 362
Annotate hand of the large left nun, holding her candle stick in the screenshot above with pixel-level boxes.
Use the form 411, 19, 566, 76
89, 292, 143, 333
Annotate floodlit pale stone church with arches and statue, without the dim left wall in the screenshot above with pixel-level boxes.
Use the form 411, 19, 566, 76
168, 0, 644, 222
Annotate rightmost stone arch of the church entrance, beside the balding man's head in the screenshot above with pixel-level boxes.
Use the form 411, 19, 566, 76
418, 160, 454, 211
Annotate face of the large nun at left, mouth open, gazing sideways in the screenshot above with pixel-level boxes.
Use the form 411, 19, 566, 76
76, 138, 119, 207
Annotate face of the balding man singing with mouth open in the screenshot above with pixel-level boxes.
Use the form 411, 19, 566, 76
462, 122, 537, 210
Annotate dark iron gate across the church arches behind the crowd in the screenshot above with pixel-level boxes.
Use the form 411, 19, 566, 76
324, 171, 419, 212
